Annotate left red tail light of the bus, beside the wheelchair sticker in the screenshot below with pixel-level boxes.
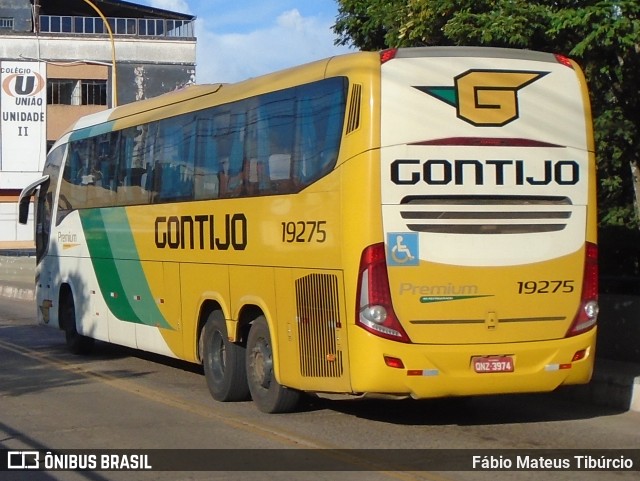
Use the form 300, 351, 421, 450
356, 244, 411, 343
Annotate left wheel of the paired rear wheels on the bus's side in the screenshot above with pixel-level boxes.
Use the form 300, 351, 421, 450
202, 311, 251, 402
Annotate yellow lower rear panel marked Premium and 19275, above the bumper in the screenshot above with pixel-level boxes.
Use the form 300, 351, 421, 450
389, 249, 585, 345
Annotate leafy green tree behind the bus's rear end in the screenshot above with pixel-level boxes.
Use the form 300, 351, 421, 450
334, 0, 640, 227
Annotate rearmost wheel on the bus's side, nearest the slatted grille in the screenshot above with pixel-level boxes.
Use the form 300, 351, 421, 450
247, 316, 300, 413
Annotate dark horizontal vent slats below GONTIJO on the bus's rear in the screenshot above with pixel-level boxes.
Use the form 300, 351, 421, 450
400, 196, 572, 234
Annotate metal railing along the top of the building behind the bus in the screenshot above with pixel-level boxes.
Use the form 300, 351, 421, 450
39, 15, 195, 38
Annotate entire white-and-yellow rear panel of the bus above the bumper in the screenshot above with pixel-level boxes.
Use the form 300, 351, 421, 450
381, 49, 594, 348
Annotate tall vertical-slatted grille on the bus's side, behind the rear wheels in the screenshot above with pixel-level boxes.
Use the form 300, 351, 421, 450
295, 274, 343, 377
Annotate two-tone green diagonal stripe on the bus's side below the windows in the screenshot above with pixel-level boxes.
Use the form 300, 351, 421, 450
80, 207, 172, 329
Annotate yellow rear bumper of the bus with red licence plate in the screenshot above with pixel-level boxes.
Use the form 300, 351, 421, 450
351, 328, 596, 399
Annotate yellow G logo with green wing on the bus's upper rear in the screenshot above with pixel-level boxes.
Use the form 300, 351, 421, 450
414, 70, 549, 127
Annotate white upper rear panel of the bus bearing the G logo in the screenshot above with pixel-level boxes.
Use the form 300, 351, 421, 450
382, 49, 590, 149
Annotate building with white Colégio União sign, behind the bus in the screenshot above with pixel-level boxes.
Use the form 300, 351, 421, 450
0, 0, 196, 248
